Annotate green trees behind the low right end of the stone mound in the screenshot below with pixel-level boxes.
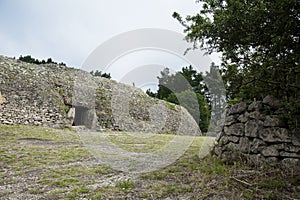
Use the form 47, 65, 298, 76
146, 66, 210, 132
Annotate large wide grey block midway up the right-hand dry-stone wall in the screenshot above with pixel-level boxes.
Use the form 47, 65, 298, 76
258, 127, 291, 142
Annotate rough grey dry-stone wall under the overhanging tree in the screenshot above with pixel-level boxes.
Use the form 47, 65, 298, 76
214, 96, 300, 171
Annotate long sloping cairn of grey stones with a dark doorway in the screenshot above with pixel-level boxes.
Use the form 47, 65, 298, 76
0, 56, 201, 135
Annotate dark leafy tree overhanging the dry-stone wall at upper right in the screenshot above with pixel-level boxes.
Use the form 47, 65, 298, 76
173, 0, 300, 131
